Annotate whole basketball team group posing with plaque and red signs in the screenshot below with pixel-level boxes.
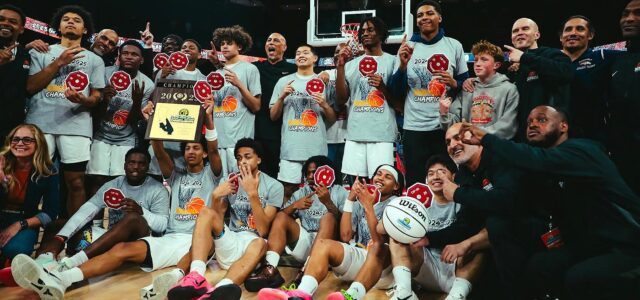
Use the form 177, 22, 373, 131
0, 0, 640, 300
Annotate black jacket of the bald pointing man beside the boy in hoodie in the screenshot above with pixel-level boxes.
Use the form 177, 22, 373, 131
509, 47, 573, 140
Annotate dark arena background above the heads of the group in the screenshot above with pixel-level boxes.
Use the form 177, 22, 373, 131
3, 0, 628, 58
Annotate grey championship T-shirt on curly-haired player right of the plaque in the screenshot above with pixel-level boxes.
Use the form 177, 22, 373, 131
213, 61, 260, 148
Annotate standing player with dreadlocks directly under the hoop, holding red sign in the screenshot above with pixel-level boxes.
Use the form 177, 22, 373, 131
336, 17, 398, 183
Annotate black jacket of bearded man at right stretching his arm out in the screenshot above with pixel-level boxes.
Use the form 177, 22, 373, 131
482, 134, 640, 252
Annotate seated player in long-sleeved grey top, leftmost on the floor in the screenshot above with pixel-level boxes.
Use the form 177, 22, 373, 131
14, 148, 169, 276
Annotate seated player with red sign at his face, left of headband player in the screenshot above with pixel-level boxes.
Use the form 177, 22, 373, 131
244, 156, 349, 292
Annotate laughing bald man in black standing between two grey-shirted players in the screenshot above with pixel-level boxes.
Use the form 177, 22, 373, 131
254, 32, 297, 178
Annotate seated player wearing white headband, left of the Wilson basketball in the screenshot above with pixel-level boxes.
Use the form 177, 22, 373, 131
258, 165, 404, 300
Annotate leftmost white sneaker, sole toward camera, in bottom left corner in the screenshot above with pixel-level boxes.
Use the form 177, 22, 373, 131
11, 254, 66, 300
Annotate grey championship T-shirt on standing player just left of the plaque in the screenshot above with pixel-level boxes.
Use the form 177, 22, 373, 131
94, 66, 154, 146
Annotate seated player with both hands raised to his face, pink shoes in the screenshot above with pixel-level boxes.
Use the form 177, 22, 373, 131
164, 138, 284, 299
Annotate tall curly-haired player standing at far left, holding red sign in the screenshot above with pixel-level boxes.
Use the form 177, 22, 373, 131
26, 6, 105, 215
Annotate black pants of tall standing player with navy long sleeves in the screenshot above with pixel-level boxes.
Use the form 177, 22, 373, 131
402, 129, 447, 187
